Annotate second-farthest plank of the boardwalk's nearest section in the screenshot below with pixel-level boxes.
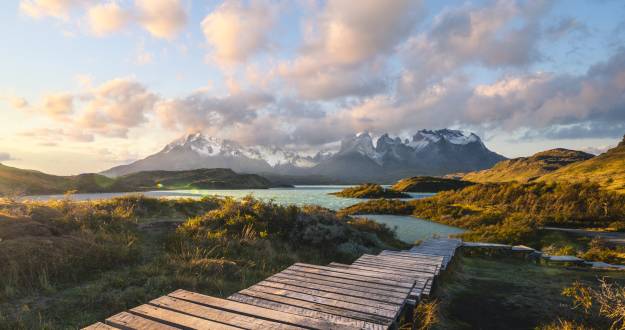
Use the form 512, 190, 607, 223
150, 296, 304, 330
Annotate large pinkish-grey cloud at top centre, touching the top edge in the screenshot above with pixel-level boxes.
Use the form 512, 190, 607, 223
278, 0, 422, 100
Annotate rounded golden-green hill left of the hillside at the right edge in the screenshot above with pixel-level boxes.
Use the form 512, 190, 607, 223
462, 148, 593, 183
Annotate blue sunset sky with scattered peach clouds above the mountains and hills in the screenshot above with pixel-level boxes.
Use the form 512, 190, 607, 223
0, 0, 625, 175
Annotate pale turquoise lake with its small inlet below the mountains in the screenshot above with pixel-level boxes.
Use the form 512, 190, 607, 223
26, 186, 463, 243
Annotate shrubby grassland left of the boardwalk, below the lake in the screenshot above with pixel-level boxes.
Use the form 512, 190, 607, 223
0, 196, 405, 329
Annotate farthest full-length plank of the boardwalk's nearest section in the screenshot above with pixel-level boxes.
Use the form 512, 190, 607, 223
169, 290, 362, 329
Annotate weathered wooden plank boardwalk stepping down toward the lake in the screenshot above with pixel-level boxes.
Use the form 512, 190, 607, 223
85, 239, 461, 330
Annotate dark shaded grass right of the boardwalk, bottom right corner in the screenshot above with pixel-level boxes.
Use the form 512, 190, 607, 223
432, 255, 625, 329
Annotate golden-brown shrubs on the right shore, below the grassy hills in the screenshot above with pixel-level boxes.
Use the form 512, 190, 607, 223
341, 182, 625, 248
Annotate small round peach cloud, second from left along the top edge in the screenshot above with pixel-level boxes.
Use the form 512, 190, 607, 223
87, 2, 131, 36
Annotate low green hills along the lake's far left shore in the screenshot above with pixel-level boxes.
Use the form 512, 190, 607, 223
0, 164, 272, 195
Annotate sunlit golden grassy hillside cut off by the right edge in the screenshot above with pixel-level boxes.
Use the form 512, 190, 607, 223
539, 137, 625, 193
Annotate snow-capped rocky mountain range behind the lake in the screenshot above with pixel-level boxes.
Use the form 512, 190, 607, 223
101, 129, 505, 183
